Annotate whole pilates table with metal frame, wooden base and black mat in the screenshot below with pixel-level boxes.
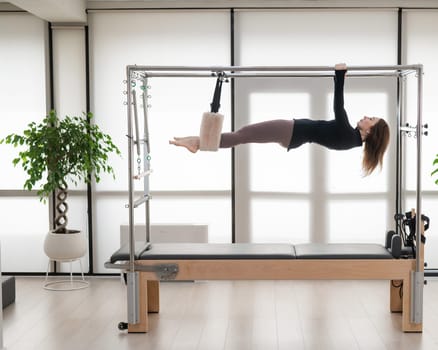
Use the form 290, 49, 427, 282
105, 65, 429, 332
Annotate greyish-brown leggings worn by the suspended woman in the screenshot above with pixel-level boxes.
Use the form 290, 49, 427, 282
219, 119, 294, 148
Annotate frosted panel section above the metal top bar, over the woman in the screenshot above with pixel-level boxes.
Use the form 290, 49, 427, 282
236, 9, 397, 65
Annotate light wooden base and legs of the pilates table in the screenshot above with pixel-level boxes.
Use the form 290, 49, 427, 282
128, 259, 423, 333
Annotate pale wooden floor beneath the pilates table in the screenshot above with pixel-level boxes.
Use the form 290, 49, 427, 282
3, 277, 438, 350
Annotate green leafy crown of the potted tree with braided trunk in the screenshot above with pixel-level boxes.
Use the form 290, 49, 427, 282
0, 111, 120, 232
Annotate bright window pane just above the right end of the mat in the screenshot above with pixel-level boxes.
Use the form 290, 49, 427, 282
328, 198, 394, 244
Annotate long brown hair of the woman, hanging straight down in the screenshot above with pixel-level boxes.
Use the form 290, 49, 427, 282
362, 119, 389, 176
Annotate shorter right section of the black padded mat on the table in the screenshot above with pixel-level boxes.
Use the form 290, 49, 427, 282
295, 243, 393, 259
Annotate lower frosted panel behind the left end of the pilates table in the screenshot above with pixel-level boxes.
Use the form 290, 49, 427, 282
95, 194, 232, 273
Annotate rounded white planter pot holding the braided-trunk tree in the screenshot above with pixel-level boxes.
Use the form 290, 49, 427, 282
44, 231, 87, 261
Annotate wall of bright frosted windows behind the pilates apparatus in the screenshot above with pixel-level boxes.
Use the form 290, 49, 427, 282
0, 8, 438, 273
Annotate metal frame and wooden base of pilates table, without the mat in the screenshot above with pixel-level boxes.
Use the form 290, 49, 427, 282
105, 64, 424, 332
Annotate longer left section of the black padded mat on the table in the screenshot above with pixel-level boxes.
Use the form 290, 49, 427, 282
140, 243, 295, 260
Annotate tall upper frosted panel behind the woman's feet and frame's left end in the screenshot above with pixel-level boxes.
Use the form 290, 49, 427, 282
89, 11, 231, 191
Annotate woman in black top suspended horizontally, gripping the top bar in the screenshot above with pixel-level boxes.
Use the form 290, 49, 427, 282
169, 63, 389, 175
